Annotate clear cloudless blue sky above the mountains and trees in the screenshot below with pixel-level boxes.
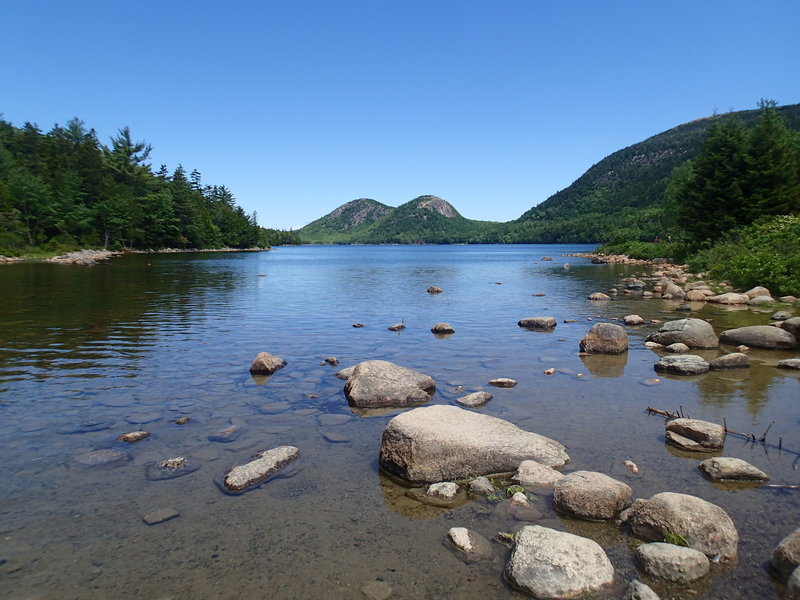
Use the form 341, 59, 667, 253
0, 0, 800, 229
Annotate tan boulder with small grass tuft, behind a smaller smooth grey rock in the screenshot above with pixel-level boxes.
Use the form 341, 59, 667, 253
628, 492, 739, 562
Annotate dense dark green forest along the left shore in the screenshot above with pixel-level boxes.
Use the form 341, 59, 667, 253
0, 119, 299, 255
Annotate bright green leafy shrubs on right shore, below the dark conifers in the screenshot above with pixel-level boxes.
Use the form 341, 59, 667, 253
695, 215, 800, 296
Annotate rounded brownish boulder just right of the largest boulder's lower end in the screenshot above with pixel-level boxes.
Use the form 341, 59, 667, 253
553, 471, 633, 521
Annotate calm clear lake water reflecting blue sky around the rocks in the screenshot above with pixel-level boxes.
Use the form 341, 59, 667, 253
0, 246, 800, 600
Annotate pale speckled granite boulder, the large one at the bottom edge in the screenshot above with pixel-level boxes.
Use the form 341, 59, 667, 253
505, 525, 614, 600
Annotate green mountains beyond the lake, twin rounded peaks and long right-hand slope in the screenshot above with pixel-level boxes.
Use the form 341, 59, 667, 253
298, 104, 800, 244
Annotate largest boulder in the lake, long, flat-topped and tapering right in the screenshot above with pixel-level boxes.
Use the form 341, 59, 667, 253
379, 405, 570, 483
